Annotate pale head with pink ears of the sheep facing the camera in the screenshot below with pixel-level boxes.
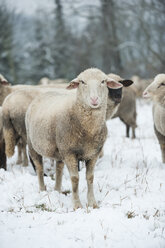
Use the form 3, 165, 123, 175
67, 68, 122, 108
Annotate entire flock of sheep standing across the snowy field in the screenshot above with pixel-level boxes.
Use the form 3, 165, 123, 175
0, 68, 165, 209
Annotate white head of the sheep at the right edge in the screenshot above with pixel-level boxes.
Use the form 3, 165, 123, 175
143, 73, 165, 103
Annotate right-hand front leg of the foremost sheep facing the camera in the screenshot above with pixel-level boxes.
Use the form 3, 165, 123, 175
86, 158, 98, 208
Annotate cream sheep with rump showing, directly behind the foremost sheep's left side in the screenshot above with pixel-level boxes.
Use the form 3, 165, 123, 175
2, 87, 72, 167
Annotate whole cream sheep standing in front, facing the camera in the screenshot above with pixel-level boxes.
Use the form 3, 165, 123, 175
25, 68, 122, 209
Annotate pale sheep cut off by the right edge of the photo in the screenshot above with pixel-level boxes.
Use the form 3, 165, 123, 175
143, 73, 165, 163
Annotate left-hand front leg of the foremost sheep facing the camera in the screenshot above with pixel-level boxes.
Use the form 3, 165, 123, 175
65, 155, 82, 209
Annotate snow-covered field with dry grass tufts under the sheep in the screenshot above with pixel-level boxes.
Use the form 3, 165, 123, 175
0, 101, 165, 248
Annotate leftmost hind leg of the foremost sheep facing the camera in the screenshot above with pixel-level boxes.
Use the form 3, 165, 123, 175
29, 141, 46, 191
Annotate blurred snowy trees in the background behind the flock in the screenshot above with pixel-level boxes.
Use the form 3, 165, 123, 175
0, 0, 165, 84
